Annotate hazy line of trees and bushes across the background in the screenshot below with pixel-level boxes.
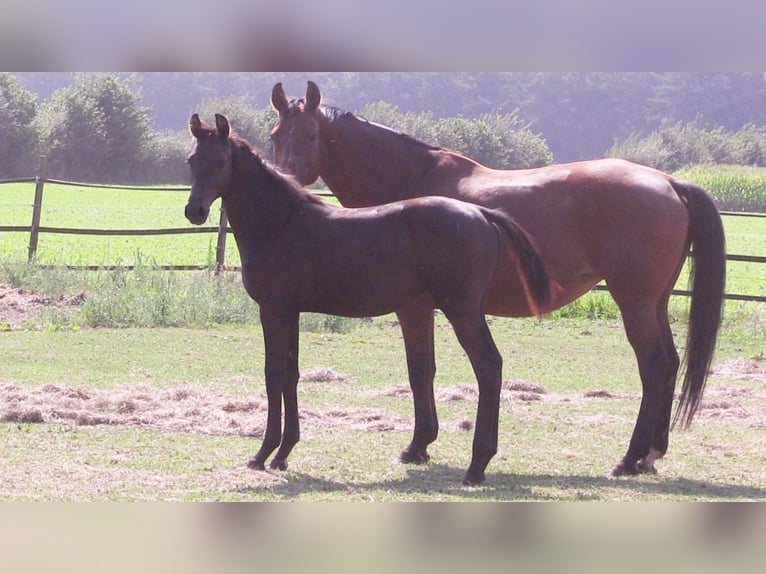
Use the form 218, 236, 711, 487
0, 73, 766, 183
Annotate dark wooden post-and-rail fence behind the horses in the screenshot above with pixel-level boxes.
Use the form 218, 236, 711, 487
0, 157, 766, 303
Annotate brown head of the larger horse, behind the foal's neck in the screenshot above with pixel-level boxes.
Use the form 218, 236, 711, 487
271, 81, 322, 185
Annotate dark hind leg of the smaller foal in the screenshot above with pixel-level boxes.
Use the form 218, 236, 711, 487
442, 307, 503, 485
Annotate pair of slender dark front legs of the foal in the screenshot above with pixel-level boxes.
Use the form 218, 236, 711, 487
247, 306, 299, 470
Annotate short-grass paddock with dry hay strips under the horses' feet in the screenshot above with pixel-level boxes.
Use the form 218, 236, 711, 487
0, 312, 766, 501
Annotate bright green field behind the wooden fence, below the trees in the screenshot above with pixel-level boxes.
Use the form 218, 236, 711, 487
0, 173, 766, 302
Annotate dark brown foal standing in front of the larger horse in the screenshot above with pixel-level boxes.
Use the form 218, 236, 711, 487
185, 114, 551, 484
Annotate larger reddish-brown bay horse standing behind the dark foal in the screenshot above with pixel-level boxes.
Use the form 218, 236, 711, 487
271, 81, 726, 476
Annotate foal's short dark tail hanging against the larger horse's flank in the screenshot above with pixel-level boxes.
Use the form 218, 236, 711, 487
481, 208, 553, 315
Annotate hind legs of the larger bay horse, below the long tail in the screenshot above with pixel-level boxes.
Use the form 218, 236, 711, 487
612, 295, 679, 476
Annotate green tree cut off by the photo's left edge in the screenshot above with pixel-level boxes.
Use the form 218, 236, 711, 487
0, 73, 37, 178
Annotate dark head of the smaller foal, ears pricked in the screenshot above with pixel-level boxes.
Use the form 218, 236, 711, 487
185, 114, 232, 225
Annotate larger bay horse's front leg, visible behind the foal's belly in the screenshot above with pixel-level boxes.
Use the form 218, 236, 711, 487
396, 295, 439, 463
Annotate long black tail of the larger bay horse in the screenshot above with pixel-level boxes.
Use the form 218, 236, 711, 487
671, 181, 726, 427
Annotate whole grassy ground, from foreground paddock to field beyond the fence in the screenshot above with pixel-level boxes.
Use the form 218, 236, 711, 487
0, 171, 766, 501
